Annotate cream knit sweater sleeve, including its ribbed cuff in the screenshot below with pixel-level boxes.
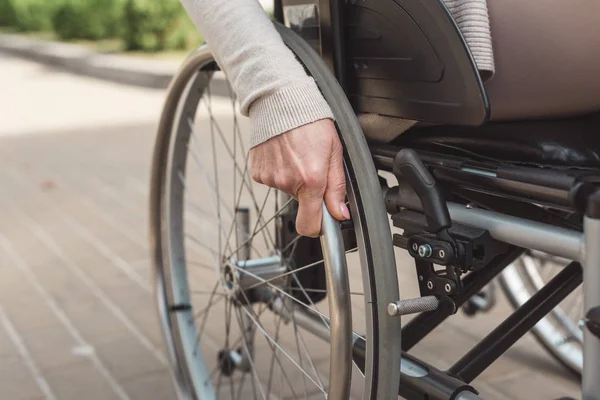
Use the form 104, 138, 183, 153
181, 0, 333, 147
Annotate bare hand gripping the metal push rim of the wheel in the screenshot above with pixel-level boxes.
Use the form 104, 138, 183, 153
250, 119, 350, 237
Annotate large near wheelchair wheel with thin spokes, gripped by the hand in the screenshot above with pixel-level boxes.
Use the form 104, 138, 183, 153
150, 23, 400, 399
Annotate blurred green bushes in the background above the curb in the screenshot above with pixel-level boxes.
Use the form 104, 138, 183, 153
0, 0, 202, 51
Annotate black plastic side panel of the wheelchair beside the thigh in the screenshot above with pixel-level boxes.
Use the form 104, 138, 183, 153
344, 0, 489, 125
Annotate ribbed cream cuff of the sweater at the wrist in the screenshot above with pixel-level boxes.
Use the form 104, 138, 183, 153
249, 79, 333, 147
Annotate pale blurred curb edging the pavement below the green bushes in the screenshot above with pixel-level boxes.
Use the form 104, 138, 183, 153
0, 34, 181, 89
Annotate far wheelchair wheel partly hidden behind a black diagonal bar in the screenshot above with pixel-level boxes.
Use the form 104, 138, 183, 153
500, 252, 583, 374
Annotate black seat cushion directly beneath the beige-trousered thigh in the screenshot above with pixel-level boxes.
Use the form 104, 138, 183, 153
393, 113, 600, 169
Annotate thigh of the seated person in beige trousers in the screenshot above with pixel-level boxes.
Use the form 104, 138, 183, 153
485, 0, 600, 120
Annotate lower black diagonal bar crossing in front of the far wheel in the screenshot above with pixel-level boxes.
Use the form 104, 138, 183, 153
448, 262, 583, 383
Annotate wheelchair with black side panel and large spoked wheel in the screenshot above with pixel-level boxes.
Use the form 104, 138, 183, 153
150, 0, 600, 400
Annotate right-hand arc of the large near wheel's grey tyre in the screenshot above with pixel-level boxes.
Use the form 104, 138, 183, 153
275, 23, 401, 399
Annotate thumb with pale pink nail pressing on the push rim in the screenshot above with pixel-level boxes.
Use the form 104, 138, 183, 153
325, 142, 350, 221
